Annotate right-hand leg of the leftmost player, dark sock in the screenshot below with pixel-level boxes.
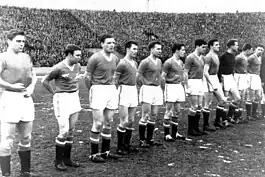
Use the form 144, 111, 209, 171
17, 121, 36, 177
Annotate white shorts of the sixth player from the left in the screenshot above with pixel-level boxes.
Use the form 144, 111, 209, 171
164, 84, 185, 103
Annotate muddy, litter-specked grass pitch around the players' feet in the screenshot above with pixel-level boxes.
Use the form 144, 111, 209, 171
4, 79, 265, 177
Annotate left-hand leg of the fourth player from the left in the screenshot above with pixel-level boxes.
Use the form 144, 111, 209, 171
117, 105, 129, 155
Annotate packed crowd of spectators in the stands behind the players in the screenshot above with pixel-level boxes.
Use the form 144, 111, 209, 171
0, 6, 265, 66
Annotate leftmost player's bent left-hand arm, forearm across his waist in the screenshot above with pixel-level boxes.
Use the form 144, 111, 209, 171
0, 56, 26, 92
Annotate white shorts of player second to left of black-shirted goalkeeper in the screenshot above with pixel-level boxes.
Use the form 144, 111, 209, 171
186, 79, 205, 96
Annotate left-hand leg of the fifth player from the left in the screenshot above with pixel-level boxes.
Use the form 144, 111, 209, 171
139, 102, 151, 148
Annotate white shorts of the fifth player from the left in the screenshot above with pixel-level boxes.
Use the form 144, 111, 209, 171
139, 85, 163, 105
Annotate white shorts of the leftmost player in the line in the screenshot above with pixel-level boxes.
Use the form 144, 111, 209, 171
0, 90, 35, 123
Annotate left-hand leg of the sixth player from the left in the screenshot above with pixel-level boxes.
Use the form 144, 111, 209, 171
163, 102, 176, 142
